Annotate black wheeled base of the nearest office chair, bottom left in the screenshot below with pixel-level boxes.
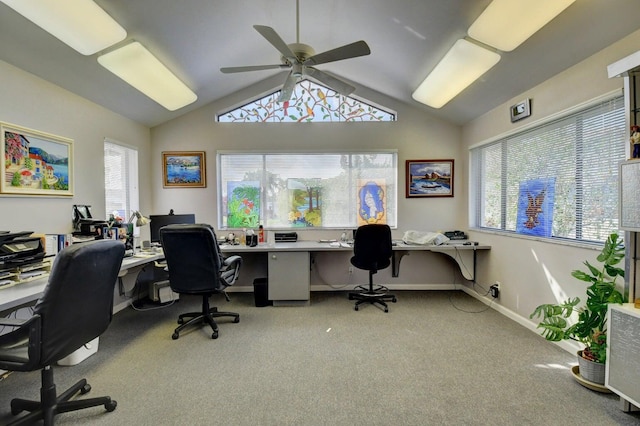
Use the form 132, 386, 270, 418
10, 366, 118, 426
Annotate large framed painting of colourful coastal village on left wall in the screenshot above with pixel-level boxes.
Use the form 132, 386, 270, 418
0, 123, 73, 196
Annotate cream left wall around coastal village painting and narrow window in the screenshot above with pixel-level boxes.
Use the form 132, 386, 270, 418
0, 61, 151, 233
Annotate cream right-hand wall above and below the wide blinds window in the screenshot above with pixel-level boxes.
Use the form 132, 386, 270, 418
461, 31, 640, 327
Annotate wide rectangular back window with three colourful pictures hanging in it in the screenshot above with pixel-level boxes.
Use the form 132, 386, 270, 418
217, 151, 398, 229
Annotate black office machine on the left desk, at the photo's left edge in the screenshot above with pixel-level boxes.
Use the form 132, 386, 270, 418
0, 231, 45, 270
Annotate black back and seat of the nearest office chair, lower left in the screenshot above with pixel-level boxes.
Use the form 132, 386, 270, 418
0, 240, 124, 371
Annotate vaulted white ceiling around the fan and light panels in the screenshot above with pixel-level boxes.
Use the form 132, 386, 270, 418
0, 0, 640, 127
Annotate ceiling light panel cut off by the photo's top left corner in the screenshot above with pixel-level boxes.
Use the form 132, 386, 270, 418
0, 0, 127, 55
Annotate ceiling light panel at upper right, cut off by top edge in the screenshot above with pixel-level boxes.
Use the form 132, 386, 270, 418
468, 0, 575, 52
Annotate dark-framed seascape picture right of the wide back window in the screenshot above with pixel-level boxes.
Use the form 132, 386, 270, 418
405, 160, 453, 198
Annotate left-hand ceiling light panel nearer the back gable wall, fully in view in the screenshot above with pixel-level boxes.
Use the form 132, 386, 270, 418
98, 41, 198, 111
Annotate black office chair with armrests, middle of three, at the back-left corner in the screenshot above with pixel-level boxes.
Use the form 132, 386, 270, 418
160, 224, 242, 340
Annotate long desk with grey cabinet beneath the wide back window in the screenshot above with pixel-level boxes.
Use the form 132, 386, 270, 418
220, 241, 491, 306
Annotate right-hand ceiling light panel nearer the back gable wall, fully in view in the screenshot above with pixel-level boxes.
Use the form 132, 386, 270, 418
411, 39, 500, 108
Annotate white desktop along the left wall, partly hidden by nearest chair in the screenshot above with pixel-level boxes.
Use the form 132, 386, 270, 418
0, 253, 164, 313
